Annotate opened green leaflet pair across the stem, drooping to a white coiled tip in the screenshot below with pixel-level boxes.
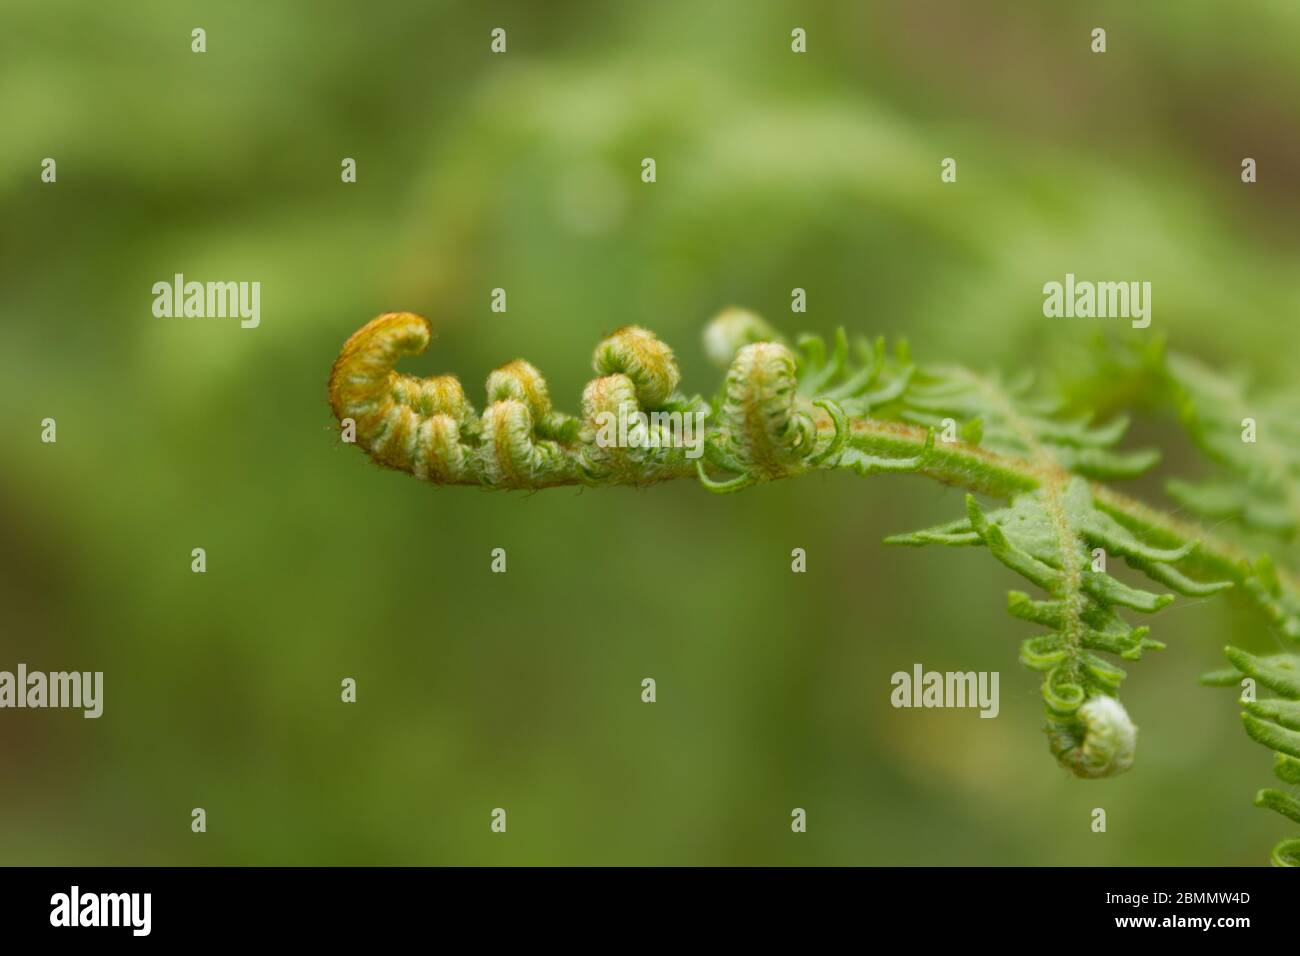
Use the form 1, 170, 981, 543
868, 351, 1231, 778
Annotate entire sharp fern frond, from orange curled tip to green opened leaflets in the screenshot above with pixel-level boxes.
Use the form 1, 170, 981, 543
329, 310, 1300, 860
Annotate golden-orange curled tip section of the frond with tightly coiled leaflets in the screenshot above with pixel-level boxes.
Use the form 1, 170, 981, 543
329, 312, 703, 489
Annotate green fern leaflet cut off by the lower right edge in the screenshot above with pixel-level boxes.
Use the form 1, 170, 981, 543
1201, 648, 1300, 866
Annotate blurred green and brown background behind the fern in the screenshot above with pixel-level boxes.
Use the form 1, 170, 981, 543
0, 0, 1300, 865
